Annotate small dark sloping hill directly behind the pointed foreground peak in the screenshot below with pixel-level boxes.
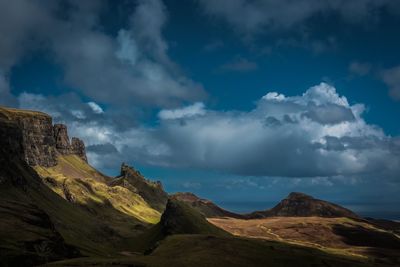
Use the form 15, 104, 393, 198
171, 192, 243, 218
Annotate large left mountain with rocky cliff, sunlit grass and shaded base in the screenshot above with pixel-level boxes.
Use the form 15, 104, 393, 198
0, 108, 166, 266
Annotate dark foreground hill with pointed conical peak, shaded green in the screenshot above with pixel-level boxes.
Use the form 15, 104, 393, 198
50, 198, 378, 267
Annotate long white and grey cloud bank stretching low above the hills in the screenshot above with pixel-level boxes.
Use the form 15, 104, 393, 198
19, 83, 400, 181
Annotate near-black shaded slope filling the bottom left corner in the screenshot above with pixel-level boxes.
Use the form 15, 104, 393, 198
0, 146, 80, 266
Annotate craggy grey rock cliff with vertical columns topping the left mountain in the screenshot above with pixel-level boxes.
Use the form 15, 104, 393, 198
0, 107, 86, 167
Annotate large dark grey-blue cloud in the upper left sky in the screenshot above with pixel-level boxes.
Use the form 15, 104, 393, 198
0, 0, 205, 107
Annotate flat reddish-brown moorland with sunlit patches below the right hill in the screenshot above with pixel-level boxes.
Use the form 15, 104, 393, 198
209, 217, 400, 266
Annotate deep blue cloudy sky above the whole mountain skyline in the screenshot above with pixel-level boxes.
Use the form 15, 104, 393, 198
0, 0, 400, 218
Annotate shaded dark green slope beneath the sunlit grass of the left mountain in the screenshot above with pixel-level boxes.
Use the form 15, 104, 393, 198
0, 151, 158, 266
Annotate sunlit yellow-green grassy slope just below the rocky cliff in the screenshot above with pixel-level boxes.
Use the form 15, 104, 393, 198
35, 155, 161, 224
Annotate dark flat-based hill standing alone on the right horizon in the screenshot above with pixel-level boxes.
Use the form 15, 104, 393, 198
246, 192, 358, 219
